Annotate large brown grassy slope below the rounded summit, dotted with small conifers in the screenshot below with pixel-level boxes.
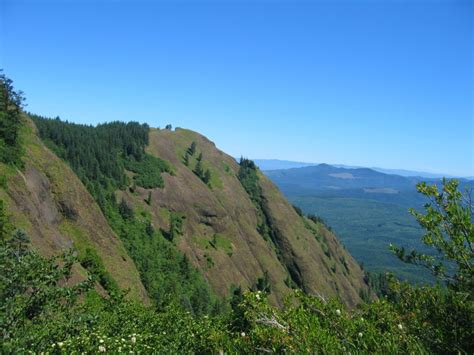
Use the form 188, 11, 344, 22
119, 128, 367, 305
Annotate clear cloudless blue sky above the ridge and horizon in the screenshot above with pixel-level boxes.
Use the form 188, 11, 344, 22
0, 0, 474, 175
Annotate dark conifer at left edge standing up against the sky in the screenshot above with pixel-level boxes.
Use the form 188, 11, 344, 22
0, 70, 24, 167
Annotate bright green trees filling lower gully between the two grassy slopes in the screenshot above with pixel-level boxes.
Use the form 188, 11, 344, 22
107, 204, 218, 314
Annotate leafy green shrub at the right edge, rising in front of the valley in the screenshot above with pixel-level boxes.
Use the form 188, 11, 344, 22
388, 179, 474, 353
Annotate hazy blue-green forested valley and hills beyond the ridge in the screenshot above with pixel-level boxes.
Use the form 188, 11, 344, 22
262, 160, 474, 282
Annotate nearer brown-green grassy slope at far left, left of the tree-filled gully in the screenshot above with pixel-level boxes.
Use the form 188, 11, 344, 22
0, 117, 148, 302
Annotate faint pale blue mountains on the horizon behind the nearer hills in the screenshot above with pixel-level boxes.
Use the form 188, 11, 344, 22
254, 159, 474, 180
